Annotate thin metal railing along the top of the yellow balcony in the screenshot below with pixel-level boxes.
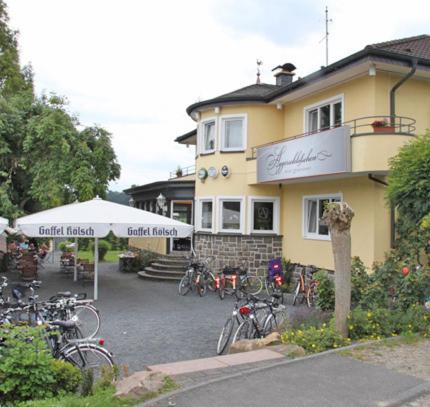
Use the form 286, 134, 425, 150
248, 116, 416, 160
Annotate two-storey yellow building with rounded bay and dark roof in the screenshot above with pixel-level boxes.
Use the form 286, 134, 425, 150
176, 35, 430, 272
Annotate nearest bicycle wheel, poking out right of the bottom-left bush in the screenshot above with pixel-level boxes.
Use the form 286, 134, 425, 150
60, 343, 114, 381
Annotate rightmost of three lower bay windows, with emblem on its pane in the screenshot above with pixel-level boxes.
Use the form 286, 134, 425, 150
248, 197, 279, 233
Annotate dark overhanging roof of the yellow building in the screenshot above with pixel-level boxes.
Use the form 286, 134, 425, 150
187, 35, 430, 115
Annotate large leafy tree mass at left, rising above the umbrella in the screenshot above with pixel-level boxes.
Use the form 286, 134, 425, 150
0, 0, 120, 218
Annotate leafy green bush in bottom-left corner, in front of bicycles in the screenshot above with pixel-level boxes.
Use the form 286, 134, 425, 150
0, 326, 81, 404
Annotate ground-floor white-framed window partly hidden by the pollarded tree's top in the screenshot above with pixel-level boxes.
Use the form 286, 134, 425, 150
303, 194, 342, 240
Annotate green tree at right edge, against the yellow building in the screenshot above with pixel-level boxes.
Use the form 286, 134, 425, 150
387, 130, 430, 259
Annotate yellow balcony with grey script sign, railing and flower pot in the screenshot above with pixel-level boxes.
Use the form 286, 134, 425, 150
247, 116, 416, 184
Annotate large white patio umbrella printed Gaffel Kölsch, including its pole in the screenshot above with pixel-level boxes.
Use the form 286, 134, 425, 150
16, 198, 194, 300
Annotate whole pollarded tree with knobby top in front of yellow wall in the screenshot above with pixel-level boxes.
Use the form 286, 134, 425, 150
322, 202, 354, 337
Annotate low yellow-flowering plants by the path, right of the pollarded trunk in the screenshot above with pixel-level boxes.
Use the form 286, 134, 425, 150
348, 304, 430, 340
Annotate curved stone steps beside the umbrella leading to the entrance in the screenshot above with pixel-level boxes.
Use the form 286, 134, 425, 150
137, 252, 189, 281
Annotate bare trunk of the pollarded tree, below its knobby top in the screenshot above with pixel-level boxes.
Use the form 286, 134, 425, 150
331, 229, 351, 337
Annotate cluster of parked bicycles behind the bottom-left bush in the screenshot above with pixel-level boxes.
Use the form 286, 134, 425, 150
0, 277, 114, 378
